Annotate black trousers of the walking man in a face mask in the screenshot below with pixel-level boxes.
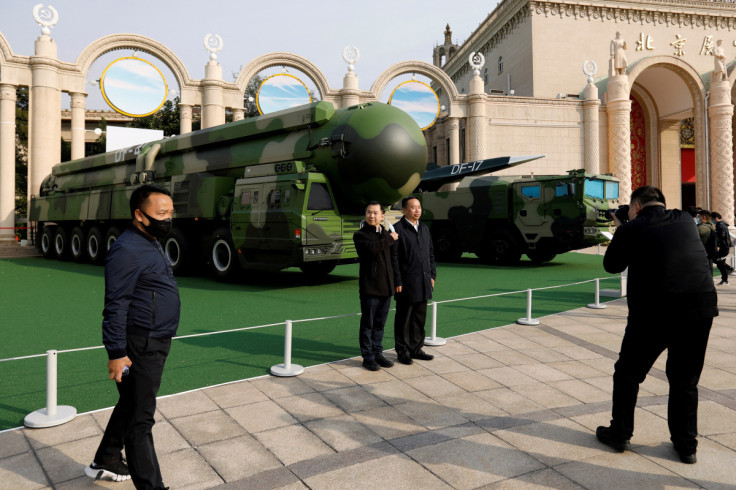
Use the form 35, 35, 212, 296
95, 333, 171, 490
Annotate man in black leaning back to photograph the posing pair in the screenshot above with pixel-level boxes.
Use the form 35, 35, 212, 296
596, 186, 718, 464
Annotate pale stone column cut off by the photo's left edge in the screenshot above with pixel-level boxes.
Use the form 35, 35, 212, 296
0, 83, 17, 242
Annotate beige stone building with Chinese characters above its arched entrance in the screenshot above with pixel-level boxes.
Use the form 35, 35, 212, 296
427, 0, 736, 223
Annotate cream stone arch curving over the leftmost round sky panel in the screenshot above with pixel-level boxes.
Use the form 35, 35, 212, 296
76, 34, 192, 90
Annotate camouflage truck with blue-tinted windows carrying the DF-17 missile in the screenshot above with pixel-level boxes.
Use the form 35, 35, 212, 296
415, 167, 618, 265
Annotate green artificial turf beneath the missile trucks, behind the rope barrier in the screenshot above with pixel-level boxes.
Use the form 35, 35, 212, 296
0, 253, 618, 430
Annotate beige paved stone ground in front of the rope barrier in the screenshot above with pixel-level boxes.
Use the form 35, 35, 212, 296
0, 286, 736, 490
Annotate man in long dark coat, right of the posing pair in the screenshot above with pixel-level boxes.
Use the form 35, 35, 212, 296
394, 197, 437, 364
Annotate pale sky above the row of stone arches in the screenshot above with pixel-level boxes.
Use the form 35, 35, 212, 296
0, 0, 498, 109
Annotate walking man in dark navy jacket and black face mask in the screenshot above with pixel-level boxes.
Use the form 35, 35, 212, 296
85, 185, 180, 489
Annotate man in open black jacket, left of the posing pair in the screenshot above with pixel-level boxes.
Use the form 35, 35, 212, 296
353, 201, 399, 371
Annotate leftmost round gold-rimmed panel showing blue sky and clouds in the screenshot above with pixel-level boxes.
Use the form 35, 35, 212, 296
100, 56, 168, 117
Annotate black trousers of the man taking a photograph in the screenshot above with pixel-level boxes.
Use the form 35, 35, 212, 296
611, 310, 713, 454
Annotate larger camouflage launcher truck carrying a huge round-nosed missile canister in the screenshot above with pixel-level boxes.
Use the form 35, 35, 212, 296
30, 102, 427, 277
